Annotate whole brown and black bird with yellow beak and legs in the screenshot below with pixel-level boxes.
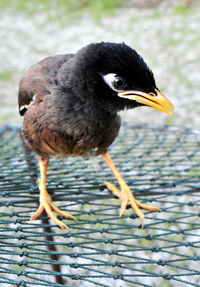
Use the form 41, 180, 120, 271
18, 42, 174, 228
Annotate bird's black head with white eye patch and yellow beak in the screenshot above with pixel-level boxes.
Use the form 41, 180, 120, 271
66, 42, 174, 114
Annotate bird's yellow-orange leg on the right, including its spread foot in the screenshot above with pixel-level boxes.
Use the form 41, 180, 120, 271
101, 153, 160, 226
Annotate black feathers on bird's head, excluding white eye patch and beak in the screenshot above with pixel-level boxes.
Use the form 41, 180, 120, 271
60, 42, 156, 112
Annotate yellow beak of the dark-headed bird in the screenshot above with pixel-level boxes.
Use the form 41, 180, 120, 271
118, 89, 174, 115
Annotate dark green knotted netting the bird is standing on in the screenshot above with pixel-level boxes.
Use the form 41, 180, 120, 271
0, 124, 200, 287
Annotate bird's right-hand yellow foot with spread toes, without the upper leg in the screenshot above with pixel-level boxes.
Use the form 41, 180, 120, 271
102, 181, 161, 227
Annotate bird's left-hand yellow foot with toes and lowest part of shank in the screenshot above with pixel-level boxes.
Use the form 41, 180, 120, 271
31, 180, 76, 229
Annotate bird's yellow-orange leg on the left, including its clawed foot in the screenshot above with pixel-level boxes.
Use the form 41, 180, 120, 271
31, 158, 75, 228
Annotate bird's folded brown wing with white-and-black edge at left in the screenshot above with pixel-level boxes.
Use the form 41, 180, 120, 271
18, 54, 73, 116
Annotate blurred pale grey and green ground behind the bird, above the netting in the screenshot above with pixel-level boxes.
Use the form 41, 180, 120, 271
0, 0, 200, 128
